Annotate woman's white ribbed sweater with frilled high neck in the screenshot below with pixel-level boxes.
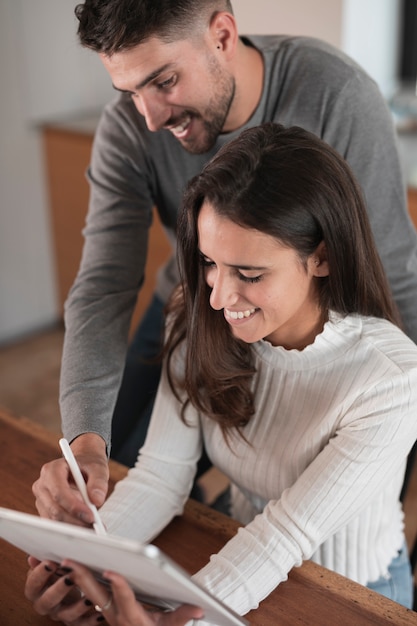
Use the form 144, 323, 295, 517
102, 314, 417, 615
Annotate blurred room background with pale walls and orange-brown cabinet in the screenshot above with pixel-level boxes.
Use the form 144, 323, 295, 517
0, 0, 417, 564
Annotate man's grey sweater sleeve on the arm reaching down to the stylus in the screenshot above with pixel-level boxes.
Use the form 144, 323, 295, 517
60, 95, 153, 450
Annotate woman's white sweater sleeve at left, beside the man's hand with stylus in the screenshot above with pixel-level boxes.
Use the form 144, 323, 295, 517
100, 360, 202, 542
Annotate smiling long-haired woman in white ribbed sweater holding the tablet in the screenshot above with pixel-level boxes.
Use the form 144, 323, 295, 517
26, 124, 417, 626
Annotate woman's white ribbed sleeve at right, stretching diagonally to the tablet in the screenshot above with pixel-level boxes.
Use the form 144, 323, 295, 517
191, 372, 417, 615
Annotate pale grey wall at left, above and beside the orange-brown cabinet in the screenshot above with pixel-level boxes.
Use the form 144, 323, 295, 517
0, 0, 112, 343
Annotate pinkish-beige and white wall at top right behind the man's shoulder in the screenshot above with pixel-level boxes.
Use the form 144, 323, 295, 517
233, 0, 402, 97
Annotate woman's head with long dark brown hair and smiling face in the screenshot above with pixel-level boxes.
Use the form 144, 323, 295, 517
168, 124, 398, 432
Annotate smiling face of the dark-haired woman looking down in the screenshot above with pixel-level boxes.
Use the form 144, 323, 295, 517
198, 202, 328, 350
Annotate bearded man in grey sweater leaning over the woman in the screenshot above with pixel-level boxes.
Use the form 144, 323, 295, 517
34, 0, 417, 523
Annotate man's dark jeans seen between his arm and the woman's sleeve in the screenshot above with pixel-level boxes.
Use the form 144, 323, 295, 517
110, 296, 211, 498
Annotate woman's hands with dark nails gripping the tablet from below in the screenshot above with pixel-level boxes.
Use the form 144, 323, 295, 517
25, 557, 203, 626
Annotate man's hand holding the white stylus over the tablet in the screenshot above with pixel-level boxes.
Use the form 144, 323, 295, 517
32, 433, 109, 526
